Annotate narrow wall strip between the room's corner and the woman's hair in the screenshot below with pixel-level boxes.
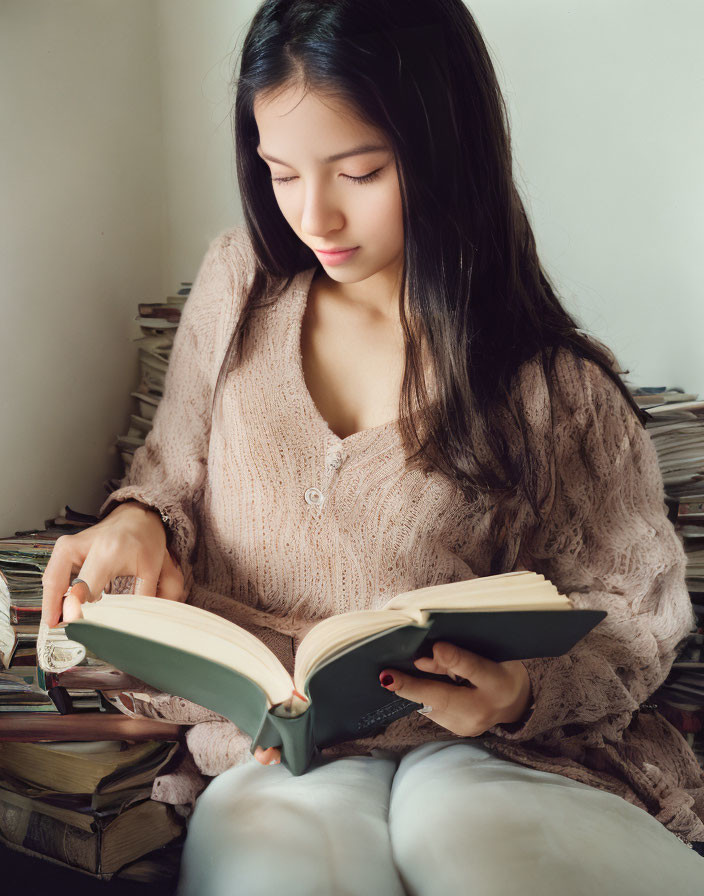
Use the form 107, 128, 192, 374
157, 0, 259, 291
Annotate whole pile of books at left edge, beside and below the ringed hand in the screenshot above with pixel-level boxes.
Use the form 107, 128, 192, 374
0, 520, 187, 881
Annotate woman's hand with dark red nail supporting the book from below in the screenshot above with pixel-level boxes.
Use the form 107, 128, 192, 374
379, 641, 532, 737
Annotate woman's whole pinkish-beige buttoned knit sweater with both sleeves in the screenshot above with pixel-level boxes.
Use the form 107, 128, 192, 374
100, 227, 704, 845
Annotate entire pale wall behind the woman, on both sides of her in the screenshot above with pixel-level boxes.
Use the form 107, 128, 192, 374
0, 0, 704, 533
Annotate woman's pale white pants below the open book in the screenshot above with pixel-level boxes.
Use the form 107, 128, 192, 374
178, 738, 704, 896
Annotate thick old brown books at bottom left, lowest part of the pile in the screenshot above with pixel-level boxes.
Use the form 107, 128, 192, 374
0, 713, 183, 879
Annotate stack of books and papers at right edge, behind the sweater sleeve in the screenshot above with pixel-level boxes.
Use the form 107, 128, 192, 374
624, 379, 704, 767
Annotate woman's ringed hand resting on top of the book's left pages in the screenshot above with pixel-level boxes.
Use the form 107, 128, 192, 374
42, 501, 186, 628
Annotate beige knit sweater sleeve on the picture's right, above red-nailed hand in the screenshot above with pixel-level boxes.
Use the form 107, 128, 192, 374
487, 350, 694, 746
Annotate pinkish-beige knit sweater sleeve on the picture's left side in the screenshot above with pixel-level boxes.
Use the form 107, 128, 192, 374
98, 230, 248, 594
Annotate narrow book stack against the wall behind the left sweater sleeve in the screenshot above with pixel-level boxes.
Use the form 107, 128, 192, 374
105, 282, 192, 494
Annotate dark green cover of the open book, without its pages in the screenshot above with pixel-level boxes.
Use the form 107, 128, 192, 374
66, 609, 606, 775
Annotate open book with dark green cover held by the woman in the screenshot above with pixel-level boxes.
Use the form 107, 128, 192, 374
57, 571, 606, 774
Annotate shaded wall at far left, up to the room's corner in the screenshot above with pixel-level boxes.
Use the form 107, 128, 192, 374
0, 0, 164, 534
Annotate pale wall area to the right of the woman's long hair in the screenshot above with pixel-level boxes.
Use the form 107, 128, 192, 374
468, 0, 704, 384
